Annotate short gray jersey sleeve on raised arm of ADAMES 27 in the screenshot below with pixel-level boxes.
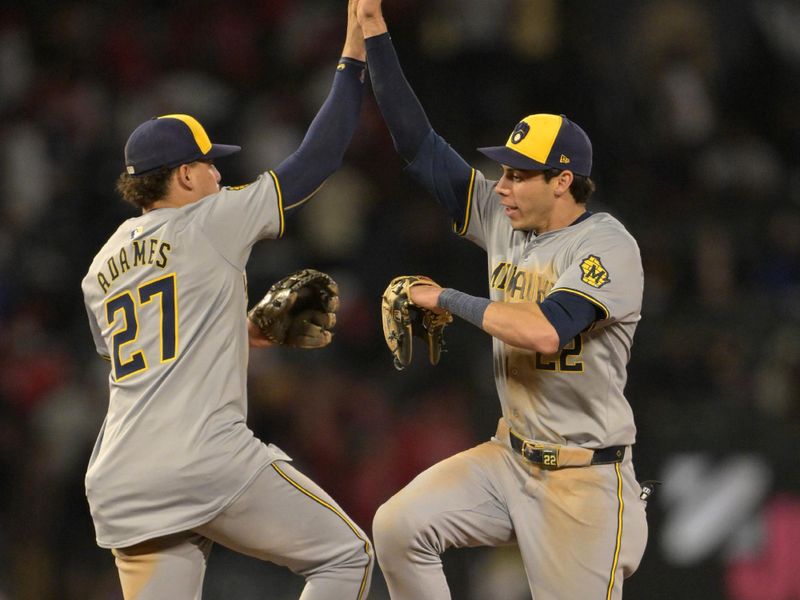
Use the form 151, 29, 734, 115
195, 171, 284, 269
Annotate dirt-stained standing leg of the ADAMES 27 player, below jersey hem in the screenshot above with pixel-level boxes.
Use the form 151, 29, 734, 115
112, 532, 213, 600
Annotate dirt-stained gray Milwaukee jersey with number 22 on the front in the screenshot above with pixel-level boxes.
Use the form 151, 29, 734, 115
460, 171, 644, 448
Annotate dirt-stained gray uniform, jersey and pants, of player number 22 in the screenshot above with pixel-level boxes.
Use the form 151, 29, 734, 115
373, 165, 647, 600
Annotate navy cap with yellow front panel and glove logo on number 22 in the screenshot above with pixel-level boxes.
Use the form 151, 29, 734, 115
478, 114, 592, 177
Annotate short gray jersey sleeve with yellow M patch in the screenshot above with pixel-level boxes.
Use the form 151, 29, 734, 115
550, 221, 644, 327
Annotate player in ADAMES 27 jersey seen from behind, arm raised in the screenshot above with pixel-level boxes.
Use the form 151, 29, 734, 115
82, 0, 374, 600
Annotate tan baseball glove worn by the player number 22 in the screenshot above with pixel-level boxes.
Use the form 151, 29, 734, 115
381, 275, 453, 371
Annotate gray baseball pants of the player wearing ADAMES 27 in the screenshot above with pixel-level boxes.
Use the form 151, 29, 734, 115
113, 461, 374, 600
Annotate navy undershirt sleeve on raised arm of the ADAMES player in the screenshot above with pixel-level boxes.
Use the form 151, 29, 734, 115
274, 57, 365, 215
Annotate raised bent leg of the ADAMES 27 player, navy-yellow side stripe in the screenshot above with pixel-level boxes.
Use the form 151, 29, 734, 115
195, 461, 374, 600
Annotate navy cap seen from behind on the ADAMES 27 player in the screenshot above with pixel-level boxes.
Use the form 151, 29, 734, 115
125, 115, 242, 175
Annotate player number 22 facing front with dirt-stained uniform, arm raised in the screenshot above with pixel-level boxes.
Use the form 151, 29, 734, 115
358, 0, 647, 600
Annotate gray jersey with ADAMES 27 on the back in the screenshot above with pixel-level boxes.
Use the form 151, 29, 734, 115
82, 172, 288, 548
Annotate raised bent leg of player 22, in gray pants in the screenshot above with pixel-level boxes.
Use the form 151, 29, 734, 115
372, 442, 514, 600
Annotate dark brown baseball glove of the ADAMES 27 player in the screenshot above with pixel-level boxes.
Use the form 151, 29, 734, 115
247, 269, 339, 348
